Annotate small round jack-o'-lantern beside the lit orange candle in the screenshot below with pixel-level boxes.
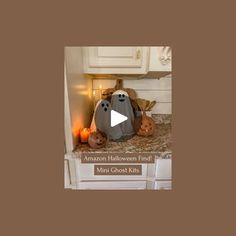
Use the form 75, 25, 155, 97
88, 130, 107, 148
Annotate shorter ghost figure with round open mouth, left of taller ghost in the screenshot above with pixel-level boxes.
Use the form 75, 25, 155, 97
93, 100, 122, 140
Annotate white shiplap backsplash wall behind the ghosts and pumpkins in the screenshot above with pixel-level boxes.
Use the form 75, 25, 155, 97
93, 77, 172, 114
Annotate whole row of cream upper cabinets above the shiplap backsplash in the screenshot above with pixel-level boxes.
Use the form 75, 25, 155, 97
83, 47, 171, 74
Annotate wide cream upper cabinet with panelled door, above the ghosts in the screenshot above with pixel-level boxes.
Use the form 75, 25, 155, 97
84, 47, 148, 74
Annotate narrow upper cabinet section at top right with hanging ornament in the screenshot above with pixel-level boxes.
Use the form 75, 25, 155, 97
148, 47, 172, 72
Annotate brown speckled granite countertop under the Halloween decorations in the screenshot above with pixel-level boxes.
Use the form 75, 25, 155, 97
75, 115, 172, 155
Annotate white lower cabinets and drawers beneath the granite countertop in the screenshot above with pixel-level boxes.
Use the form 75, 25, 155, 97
64, 153, 172, 190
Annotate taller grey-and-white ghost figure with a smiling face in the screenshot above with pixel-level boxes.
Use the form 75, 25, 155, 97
111, 90, 135, 137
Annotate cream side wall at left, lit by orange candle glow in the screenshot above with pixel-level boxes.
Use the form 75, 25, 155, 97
65, 47, 93, 152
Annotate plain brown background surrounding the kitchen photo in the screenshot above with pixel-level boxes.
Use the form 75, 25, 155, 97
0, 0, 235, 235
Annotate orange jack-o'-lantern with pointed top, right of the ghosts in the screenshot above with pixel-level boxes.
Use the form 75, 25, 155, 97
137, 111, 155, 136
